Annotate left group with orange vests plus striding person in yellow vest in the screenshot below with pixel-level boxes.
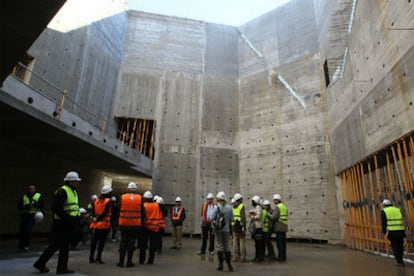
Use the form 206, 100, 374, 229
30, 171, 186, 274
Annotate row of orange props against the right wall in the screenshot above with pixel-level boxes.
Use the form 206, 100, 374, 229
339, 132, 414, 261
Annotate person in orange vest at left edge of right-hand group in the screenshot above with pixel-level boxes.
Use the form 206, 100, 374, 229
197, 193, 216, 255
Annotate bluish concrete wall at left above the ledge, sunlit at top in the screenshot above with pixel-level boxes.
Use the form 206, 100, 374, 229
29, 0, 127, 135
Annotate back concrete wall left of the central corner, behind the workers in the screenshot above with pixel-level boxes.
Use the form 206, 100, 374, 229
115, 11, 238, 233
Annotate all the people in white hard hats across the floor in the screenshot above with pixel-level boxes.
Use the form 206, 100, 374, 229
18, 171, 405, 274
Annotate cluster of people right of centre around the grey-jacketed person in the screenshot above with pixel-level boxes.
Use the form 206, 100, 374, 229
198, 192, 288, 271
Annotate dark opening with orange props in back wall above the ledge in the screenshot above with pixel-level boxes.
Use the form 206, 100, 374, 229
115, 118, 156, 160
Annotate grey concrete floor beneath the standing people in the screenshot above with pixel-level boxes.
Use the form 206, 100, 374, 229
0, 236, 414, 276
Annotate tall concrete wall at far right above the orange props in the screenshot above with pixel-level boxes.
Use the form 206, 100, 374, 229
327, 1, 414, 173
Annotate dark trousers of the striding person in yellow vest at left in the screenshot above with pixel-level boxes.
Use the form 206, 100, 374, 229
36, 220, 74, 271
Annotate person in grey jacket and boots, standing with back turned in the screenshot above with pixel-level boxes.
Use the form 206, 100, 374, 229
211, 191, 233, 271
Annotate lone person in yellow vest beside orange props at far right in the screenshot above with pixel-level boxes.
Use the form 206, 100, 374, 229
381, 199, 405, 266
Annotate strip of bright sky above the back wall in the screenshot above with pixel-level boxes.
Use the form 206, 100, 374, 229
128, 0, 291, 26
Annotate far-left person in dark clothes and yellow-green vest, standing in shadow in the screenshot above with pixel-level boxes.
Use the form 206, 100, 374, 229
17, 185, 44, 252
